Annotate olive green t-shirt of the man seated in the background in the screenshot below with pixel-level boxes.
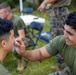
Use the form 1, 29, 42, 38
11, 14, 28, 36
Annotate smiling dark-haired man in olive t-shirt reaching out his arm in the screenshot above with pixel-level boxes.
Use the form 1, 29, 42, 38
15, 11, 76, 75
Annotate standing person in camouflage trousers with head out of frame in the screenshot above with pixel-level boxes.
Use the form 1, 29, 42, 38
38, 0, 71, 74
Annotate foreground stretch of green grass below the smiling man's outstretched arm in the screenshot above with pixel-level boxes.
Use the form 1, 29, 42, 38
4, 52, 55, 75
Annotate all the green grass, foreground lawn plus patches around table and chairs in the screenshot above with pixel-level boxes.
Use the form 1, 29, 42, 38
3, 6, 74, 75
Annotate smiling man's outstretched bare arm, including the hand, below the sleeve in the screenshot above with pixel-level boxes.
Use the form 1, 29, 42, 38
15, 39, 51, 61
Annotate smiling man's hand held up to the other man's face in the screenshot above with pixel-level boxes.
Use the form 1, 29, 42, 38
15, 38, 26, 56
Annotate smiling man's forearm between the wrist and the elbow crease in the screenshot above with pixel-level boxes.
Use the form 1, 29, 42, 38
23, 49, 43, 62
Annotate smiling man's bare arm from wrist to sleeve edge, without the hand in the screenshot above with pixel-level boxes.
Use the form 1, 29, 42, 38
23, 47, 50, 61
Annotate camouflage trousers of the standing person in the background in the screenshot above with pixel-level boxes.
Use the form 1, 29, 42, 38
49, 7, 68, 68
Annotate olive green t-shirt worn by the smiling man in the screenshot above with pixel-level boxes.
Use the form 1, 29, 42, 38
45, 35, 76, 75
